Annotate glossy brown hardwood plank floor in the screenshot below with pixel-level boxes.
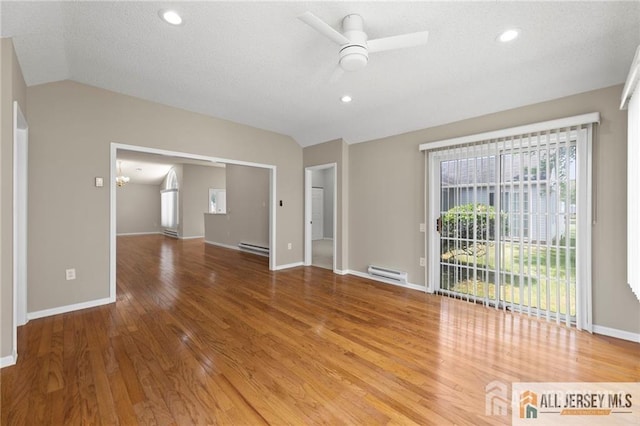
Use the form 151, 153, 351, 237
1, 236, 640, 425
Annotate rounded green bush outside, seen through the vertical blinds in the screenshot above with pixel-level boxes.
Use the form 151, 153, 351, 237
441, 203, 508, 240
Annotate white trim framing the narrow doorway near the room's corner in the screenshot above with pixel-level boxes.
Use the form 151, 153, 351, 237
304, 163, 338, 272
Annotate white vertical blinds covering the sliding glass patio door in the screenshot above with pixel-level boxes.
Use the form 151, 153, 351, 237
420, 115, 597, 327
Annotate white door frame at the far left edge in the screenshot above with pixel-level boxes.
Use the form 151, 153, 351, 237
13, 101, 29, 360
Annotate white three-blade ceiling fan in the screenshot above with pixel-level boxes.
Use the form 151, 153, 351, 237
298, 12, 429, 71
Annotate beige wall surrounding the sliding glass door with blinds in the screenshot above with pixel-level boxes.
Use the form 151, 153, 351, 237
349, 86, 640, 333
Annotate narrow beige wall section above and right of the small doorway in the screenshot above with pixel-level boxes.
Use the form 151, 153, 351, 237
302, 139, 350, 271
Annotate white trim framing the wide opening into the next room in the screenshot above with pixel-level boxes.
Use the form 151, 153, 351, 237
109, 142, 277, 302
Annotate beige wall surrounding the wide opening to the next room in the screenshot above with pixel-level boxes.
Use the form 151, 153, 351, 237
27, 81, 302, 312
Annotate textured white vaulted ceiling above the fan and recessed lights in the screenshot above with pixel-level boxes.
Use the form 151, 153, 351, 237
0, 1, 640, 146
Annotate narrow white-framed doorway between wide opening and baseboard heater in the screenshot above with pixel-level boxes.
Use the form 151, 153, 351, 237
304, 163, 337, 271
